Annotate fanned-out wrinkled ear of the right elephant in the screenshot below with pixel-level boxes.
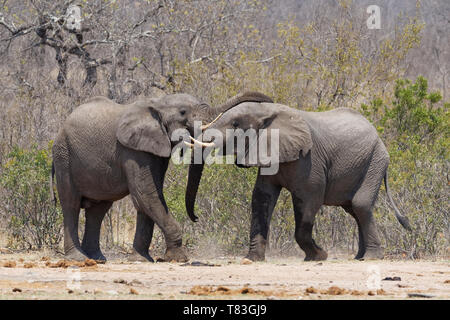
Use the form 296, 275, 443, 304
255, 104, 313, 165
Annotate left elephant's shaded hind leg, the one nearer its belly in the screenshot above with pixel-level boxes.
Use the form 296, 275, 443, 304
81, 201, 112, 261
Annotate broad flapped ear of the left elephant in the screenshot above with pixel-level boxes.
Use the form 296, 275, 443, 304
116, 102, 171, 158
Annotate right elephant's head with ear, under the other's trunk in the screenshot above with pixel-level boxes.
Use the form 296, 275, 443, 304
199, 103, 312, 162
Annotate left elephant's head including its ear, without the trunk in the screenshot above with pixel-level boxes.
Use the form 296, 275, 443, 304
117, 94, 213, 157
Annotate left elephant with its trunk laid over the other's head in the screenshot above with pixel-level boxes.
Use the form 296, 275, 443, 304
50, 93, 268, 262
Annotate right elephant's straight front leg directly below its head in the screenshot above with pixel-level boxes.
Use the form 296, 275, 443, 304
246, 175, 281, 261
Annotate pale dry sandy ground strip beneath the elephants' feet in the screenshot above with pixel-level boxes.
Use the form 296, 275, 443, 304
0, 253, 450, 299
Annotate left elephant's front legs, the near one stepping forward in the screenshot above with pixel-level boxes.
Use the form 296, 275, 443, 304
127, 163, 188, 262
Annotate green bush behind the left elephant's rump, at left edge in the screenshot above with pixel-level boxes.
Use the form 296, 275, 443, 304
0, 145, 62, 249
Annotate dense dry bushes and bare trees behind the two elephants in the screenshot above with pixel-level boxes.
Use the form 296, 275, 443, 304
0, 0, 450, 258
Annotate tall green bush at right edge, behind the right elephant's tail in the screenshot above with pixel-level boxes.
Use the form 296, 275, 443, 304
362, 77, 450, 257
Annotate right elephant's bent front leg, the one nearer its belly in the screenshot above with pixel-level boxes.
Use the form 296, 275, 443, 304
292, 195, 328, 261
